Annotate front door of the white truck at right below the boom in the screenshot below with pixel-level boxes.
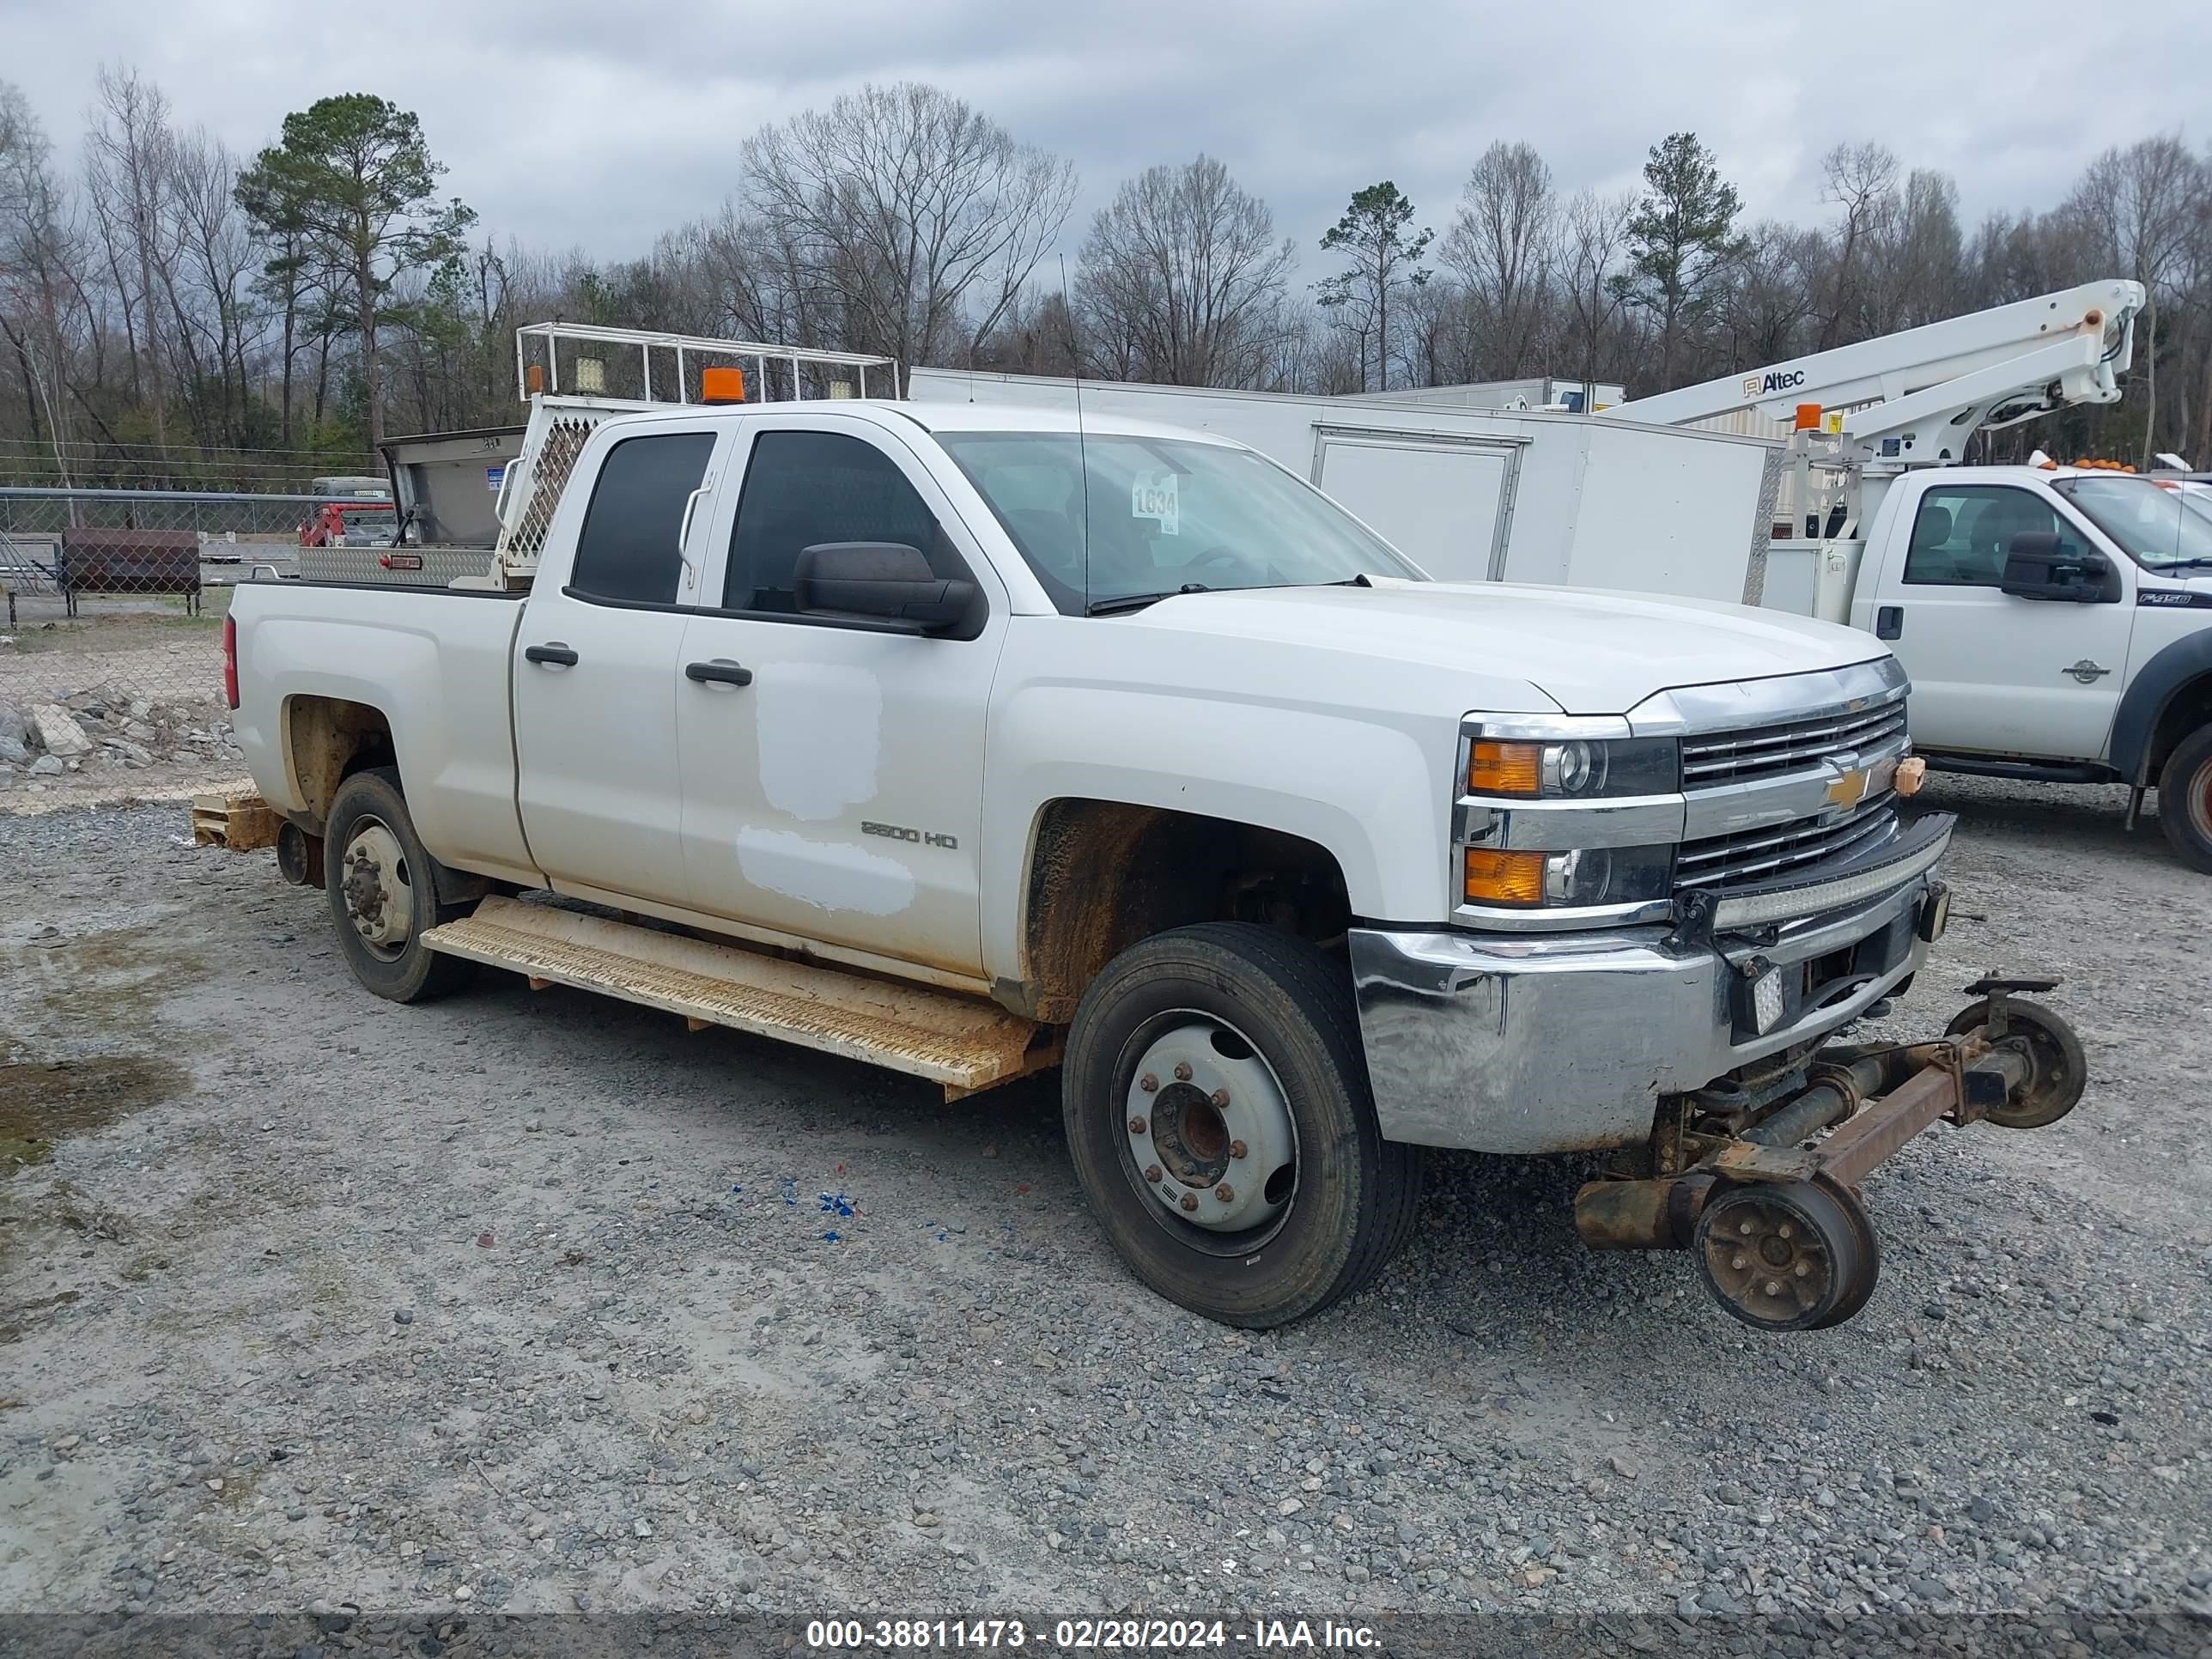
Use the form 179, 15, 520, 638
1854, 483, 2135, 761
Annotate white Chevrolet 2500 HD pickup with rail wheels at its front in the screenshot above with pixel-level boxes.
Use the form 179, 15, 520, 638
226, 400, 2084, 1329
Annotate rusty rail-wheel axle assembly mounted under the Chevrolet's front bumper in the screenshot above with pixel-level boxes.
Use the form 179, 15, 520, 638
1575, 978, 2088, 1332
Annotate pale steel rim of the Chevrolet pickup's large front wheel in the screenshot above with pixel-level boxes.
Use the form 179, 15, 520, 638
1121, 1009, 1298, 1255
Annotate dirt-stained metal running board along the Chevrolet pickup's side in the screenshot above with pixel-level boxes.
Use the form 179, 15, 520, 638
422, 898, 1060, 1099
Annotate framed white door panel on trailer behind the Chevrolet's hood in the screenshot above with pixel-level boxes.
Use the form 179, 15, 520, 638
1314, 427, 1526, 581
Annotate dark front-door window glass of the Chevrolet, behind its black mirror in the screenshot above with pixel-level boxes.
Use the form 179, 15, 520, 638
721, 431, 967, 615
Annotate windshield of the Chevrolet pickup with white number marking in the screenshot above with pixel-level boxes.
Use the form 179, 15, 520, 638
936, 431, 1418, 615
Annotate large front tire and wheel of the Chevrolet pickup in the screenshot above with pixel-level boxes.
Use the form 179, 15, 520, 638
1061, 922, 1420, 1328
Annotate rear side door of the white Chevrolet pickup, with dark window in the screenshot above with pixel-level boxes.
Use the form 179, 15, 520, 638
514, 422, 730, 905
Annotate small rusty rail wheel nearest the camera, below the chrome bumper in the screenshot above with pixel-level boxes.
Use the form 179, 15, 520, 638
1694, 1182, 1882, 1332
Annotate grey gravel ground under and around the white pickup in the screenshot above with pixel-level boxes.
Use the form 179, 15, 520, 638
0, 779, 2212, 1652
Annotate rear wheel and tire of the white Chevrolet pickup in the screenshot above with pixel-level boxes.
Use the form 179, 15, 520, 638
323, 765, 476, 1002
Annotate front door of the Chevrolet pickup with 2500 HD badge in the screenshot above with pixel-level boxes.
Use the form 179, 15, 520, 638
677, 414, 1005, 973
